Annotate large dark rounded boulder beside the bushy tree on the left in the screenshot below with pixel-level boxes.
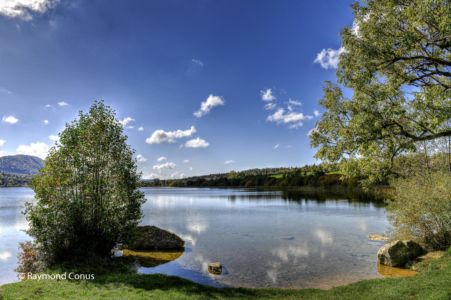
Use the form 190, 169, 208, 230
126, 226, 185, 251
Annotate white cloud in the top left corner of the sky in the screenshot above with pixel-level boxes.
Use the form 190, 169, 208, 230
0, 0, 59, 21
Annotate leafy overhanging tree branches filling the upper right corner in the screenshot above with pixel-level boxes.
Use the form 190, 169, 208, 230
310, 0, 451, 180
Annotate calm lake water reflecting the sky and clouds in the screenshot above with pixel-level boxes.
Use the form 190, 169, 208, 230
0, 188, 389, 288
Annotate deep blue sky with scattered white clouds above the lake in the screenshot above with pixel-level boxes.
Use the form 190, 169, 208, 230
0, 0, 353, 178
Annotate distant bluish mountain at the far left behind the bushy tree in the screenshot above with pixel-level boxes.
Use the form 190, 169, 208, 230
0, 155, 44, 175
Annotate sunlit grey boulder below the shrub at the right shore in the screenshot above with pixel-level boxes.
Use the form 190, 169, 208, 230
377, 240, 425, 267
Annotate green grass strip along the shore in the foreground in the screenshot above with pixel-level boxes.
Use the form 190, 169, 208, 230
0, 249, 451, 300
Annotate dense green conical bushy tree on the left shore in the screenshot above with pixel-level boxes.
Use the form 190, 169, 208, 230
25, 102, 144, 262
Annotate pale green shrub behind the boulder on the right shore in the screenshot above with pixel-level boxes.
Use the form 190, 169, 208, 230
388, 172, 451, 250
